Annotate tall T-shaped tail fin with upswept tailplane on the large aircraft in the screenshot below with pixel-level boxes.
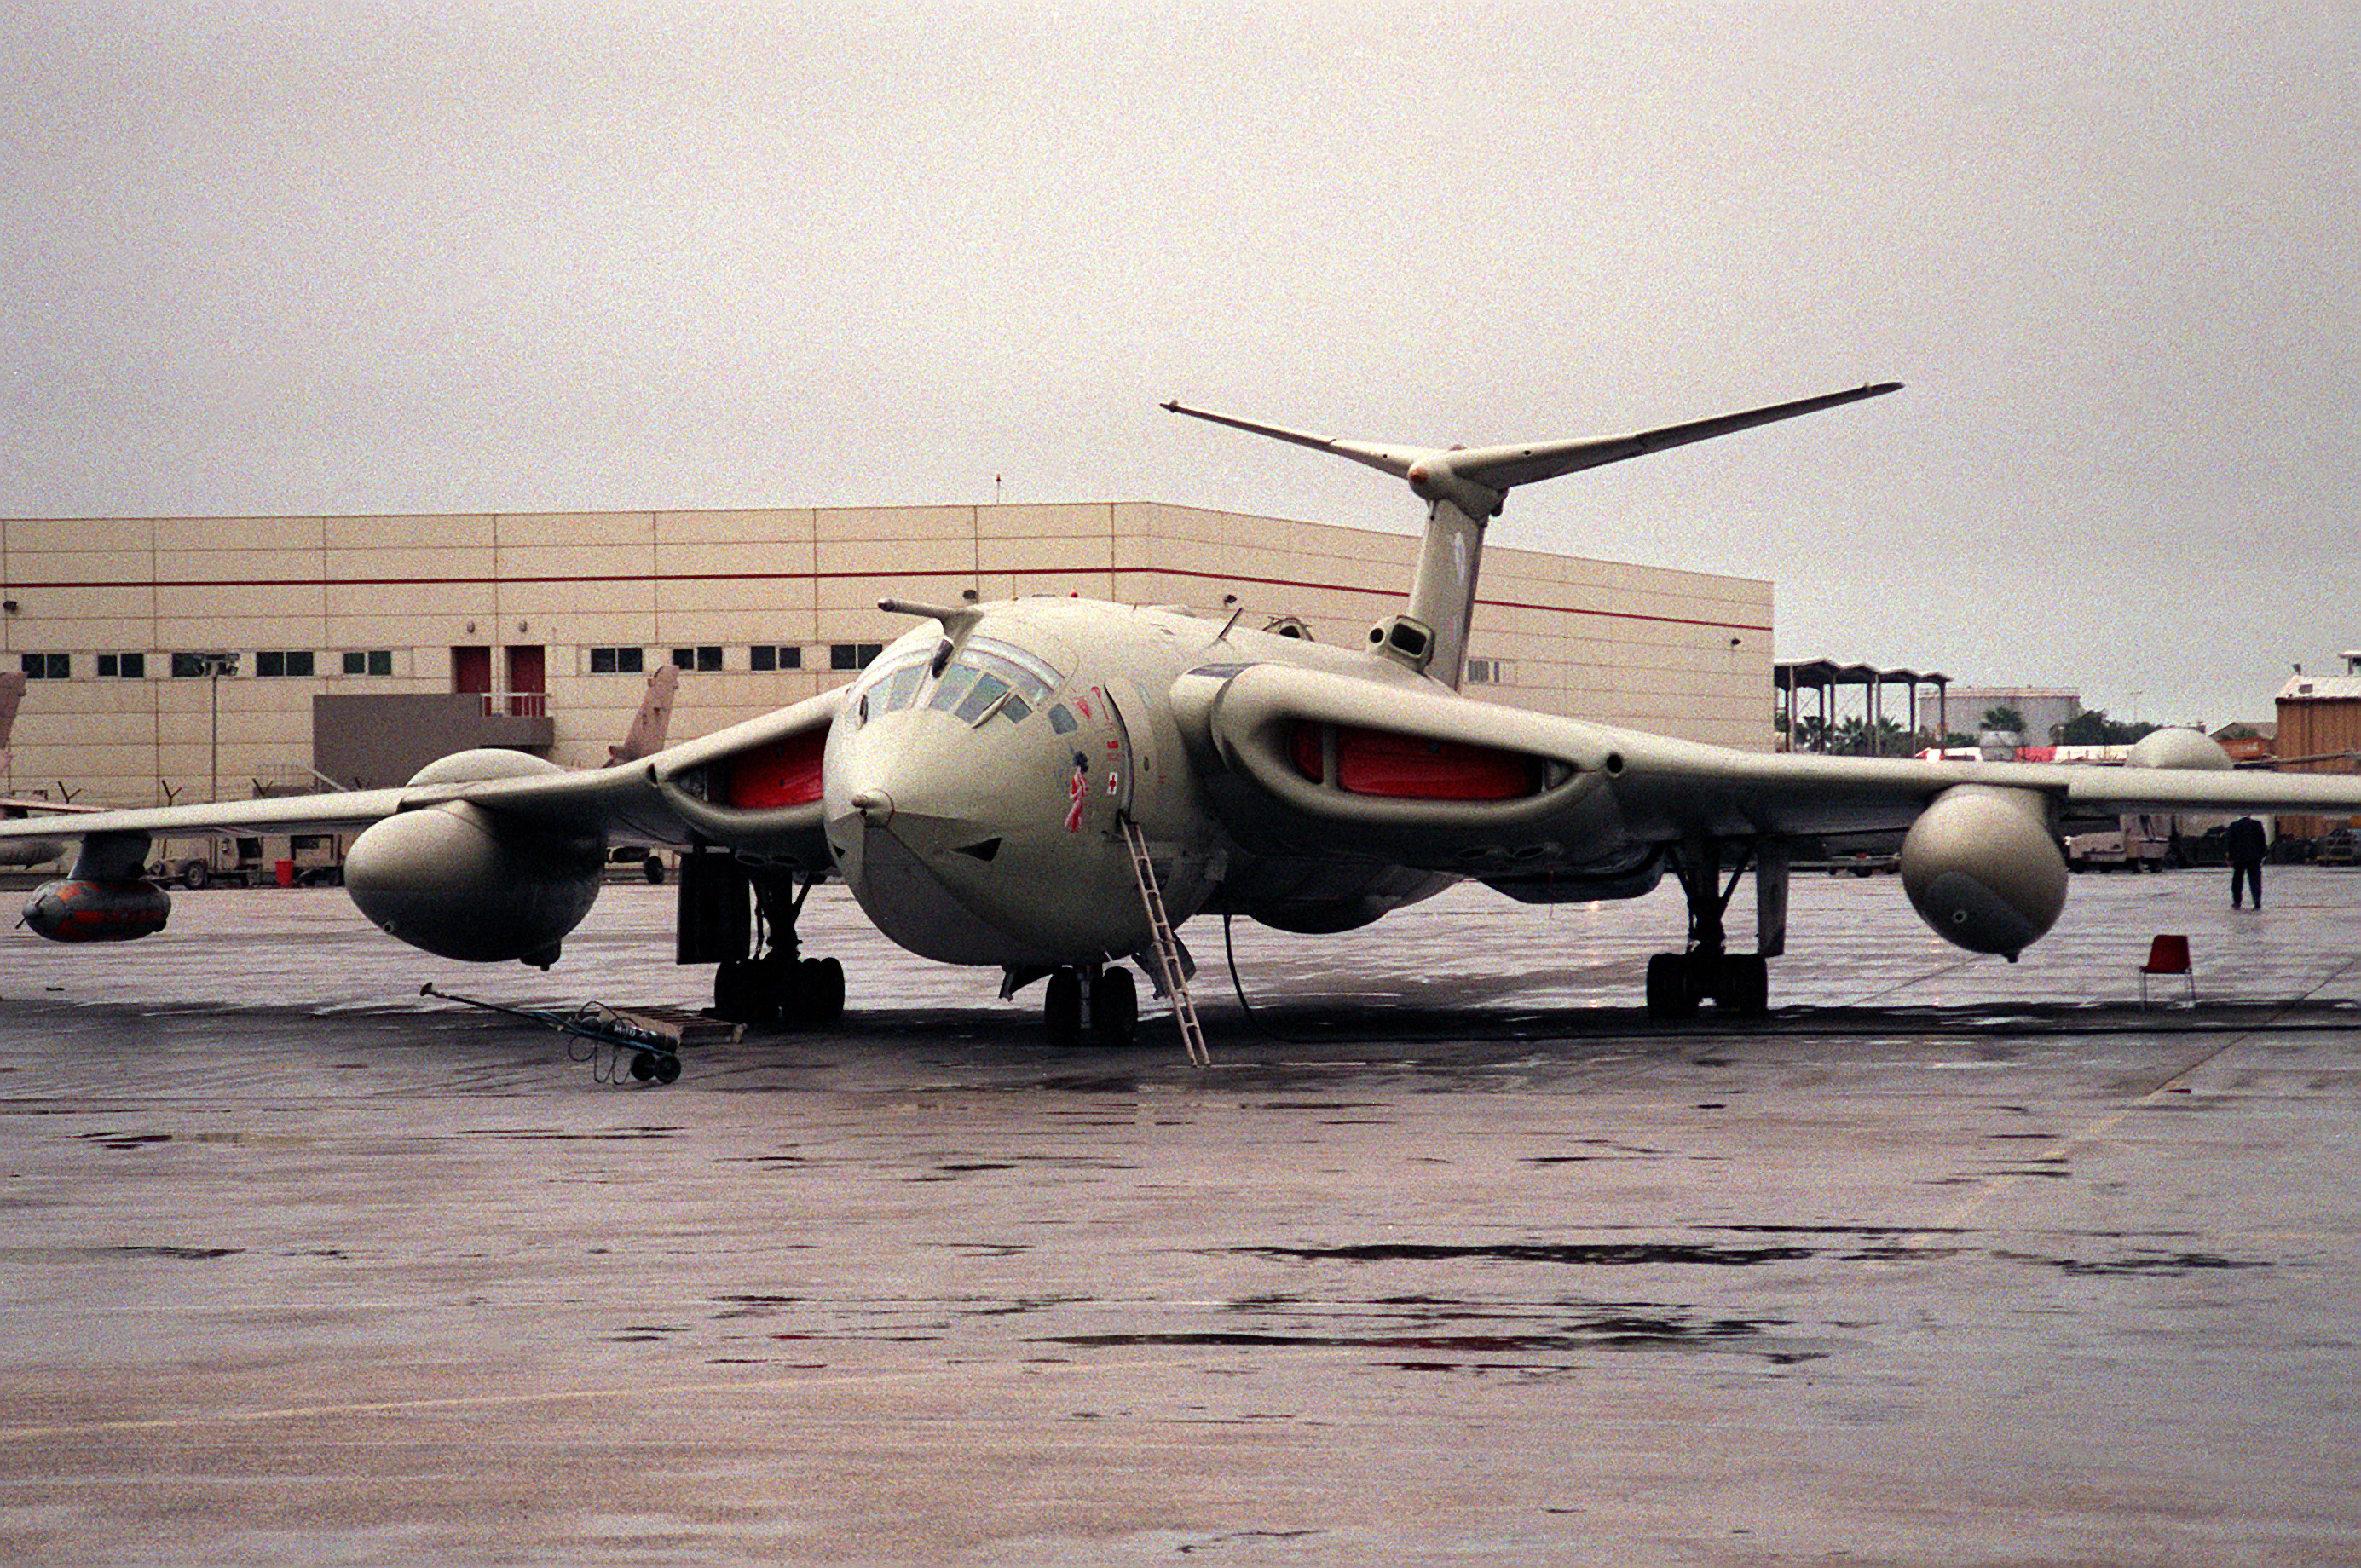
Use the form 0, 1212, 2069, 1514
1164, 380, 1901, 689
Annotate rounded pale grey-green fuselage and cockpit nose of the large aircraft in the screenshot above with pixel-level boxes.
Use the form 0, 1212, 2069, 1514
822, 597, 1452, 968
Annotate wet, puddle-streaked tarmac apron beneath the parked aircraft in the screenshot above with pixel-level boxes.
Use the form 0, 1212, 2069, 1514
0, 869, 2361, 1563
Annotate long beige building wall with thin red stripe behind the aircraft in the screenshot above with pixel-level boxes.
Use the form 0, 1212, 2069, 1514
0, 503, 1771, 805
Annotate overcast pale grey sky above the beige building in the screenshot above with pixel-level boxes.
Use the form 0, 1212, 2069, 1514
0, 0, 2361, 723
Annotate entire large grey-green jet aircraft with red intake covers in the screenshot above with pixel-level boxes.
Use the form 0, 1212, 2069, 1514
0, 383, 2361, 1041
